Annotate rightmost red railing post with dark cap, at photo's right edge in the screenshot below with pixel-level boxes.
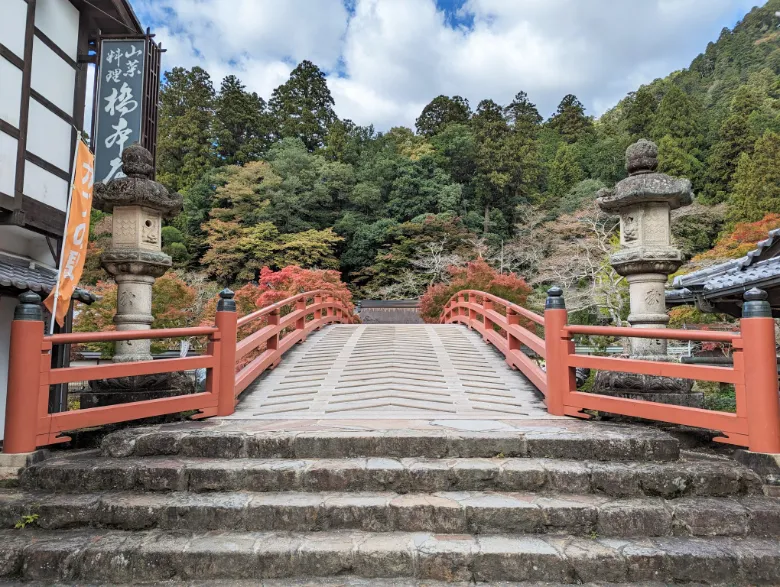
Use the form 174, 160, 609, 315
740, 288, 780, 454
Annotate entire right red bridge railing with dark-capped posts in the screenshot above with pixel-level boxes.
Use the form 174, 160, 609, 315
441, 288, 780, 453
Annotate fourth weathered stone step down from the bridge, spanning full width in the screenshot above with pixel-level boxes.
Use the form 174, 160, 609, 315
0, 530, 780, 585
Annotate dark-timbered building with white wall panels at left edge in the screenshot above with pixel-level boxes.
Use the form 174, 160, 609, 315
0, 0, 144, 438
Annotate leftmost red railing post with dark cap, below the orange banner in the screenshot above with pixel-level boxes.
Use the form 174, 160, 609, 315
3, 291, 48, 454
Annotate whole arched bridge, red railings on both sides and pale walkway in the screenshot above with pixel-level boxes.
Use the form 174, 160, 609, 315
3, 288, 780, 453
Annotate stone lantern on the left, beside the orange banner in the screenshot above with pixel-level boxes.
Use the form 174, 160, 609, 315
82, 144, 182, 405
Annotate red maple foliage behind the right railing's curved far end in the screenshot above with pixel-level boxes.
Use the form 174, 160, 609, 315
420, 259, 532, 324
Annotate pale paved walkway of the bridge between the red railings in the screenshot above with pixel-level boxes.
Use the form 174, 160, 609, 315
230, 324, 554, 420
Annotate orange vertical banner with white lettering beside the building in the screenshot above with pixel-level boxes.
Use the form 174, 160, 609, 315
43, 140, 95, 326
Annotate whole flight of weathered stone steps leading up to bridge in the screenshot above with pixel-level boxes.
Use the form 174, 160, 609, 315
0, 421, 780, 586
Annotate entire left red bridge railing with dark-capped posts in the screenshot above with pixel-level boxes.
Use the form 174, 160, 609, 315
3, 290, 354, 453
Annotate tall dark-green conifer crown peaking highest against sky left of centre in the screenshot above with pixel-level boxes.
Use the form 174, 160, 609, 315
268, 60, 337, 151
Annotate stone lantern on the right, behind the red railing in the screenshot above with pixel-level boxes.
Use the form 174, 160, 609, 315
596, 139, 701, 405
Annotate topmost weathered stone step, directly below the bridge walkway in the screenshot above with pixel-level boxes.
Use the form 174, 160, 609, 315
102, 421, 680, 461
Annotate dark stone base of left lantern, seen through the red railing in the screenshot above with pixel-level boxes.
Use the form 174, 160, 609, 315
81, 373, 197, 408
